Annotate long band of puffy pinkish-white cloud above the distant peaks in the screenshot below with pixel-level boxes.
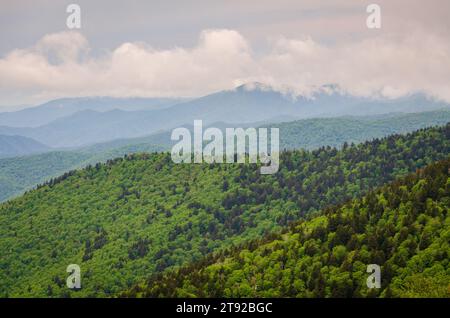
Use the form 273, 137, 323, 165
0, 29, 450, 102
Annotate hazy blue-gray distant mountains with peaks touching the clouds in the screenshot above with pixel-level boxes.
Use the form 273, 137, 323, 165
0, 84, 450, 148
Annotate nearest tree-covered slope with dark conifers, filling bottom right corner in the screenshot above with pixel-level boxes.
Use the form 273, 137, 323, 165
123, 159, 450, 297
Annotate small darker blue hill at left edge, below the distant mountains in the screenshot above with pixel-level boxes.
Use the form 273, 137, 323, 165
0, 135, 50, 158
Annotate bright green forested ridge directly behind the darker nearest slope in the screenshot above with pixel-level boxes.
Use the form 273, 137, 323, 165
0, 124, 450, 297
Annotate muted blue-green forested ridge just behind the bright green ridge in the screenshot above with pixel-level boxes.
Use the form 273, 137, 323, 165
0, 110, 450, 202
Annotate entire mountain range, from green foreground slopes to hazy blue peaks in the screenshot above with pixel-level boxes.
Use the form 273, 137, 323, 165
0, 85, 450, 297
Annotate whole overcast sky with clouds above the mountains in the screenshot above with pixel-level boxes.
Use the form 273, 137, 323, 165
0, 0, 450, 109
